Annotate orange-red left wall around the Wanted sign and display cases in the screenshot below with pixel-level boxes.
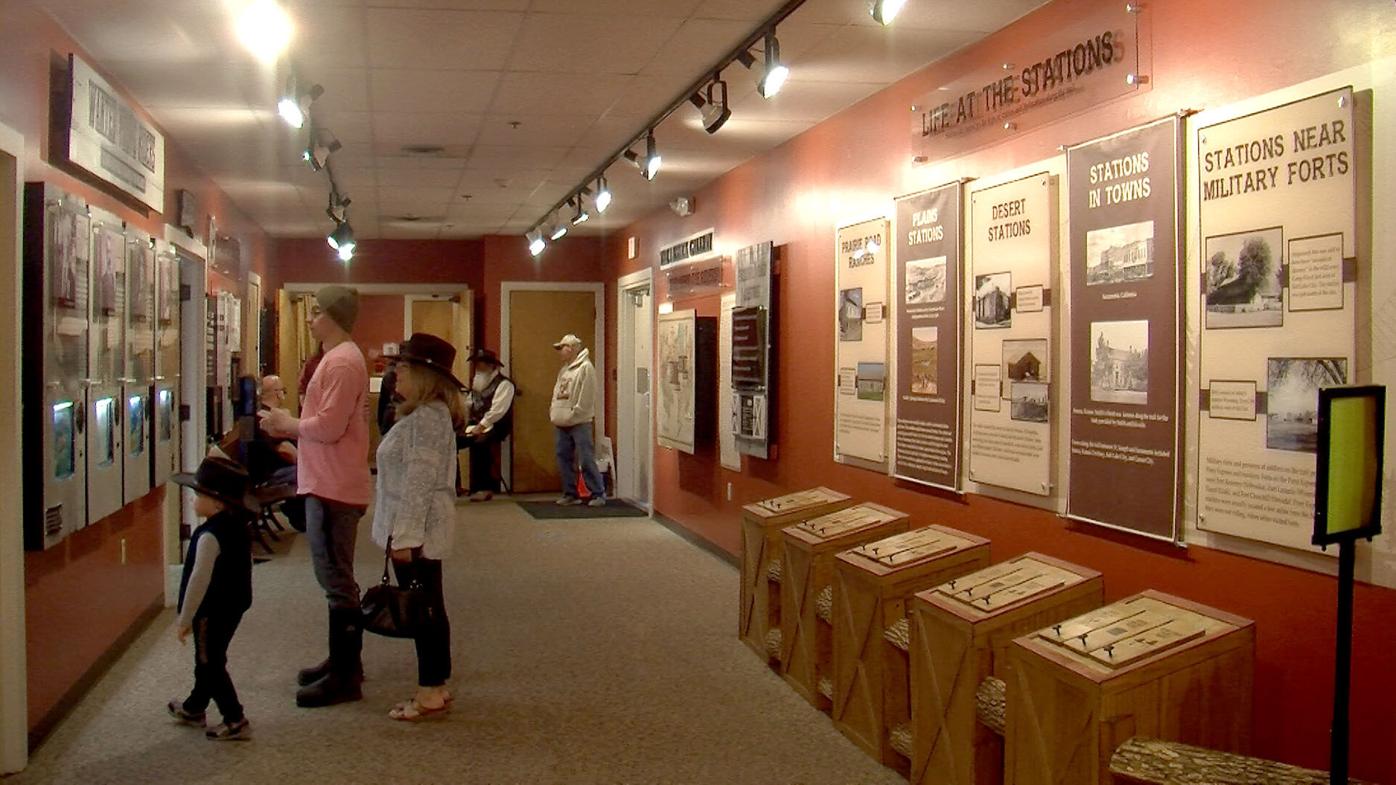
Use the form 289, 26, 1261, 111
0, 3, 271, 731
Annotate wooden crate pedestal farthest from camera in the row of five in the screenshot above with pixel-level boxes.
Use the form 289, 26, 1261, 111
737, 487, 853, 665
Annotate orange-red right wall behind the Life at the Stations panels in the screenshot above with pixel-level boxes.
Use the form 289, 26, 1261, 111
604, 0, 1396, 782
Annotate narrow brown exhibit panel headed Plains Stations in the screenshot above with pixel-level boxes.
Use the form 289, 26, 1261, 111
892, 182, 963, 492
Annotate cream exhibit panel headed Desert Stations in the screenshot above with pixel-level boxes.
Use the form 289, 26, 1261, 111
969, 173, 1057, 496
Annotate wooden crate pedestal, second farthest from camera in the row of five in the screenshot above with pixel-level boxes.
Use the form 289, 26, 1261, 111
780, 501, 912, 711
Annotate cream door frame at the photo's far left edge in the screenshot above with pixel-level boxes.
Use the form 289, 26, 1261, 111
0, 117, 29, 774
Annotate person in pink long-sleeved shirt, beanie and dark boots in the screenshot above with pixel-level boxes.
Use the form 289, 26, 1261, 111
260, 286, 373, 707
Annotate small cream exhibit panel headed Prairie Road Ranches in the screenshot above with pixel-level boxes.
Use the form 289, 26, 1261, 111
833, 218, 888, 465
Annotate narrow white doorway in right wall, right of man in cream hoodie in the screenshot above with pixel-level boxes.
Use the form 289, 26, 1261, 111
616, 270, 655, 507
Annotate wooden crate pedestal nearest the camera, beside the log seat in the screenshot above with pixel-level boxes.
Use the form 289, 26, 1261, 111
1004, 591, 1255, 785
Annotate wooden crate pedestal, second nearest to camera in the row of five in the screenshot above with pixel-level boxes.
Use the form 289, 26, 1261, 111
909, 553, 1103, 785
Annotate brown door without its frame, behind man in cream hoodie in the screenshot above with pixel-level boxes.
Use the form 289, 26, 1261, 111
516, 291, 602, 493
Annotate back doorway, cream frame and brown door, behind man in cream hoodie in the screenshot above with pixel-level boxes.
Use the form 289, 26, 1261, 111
501, 284, 606, 493
